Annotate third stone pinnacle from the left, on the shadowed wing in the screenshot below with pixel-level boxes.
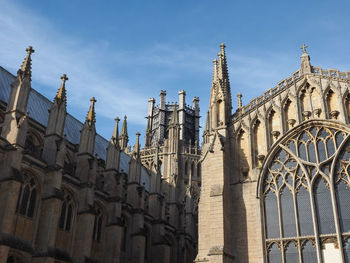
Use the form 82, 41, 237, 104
79, 97, 96, 155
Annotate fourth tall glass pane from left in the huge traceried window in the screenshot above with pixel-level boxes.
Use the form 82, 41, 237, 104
314, 178, 335, 234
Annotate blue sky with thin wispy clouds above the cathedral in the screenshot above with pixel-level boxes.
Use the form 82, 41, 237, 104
0, 0, 350, 145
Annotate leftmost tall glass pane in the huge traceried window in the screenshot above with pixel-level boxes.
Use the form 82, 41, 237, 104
264, 191, 280, 238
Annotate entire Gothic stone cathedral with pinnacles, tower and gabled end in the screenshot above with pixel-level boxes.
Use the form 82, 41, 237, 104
0, 44, 350, 263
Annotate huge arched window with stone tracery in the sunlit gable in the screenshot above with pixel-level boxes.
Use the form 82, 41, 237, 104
259, 121, 350, 263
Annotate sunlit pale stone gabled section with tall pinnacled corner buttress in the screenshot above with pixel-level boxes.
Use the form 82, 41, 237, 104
195, 44, 350, 263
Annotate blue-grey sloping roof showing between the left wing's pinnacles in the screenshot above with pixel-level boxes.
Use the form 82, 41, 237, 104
0, 66, 135, 177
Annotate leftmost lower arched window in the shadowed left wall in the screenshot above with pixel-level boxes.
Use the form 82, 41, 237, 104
16, 173, 38, 218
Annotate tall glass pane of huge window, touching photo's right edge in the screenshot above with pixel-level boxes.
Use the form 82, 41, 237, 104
335, 180, 350, 232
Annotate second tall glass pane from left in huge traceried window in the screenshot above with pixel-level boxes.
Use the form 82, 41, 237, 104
281, 187, 297, 237
